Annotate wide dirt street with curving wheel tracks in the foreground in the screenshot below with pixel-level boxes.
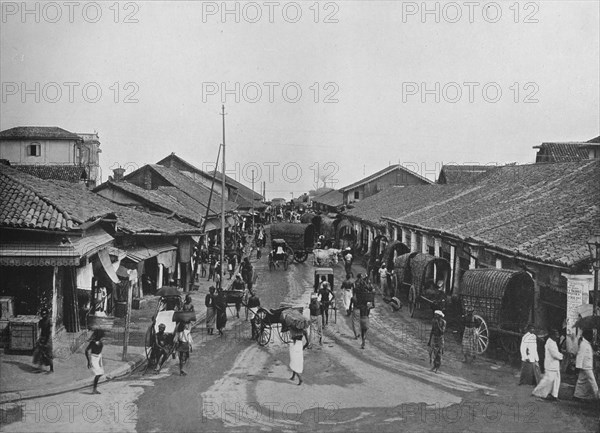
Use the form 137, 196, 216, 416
2, 258, 598, 432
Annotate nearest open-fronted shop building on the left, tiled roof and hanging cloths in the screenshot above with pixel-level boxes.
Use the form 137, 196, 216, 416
0, 165, 201, 334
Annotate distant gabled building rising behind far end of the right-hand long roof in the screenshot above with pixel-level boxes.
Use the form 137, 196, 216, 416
339, 164, 433, 205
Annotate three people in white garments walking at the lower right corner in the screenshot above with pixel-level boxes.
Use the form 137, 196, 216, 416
519, 325, 600, 401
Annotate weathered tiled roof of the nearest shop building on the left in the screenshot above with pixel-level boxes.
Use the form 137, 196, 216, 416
0, 165, 198, 234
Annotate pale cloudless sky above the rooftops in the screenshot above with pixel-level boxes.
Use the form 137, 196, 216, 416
0, 0, 600, 198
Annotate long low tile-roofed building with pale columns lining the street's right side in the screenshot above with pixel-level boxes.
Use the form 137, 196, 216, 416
376, 160, 600, 329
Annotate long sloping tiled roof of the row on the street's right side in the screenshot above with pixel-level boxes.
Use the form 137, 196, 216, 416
346, 160, 600, 267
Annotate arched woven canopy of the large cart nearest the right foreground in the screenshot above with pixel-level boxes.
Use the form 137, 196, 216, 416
458, 269, 534, 331
